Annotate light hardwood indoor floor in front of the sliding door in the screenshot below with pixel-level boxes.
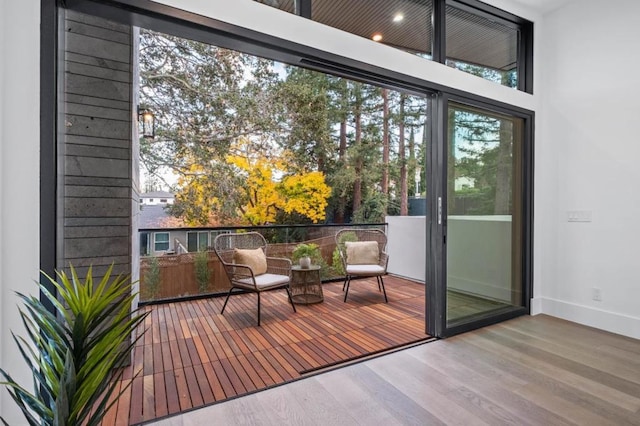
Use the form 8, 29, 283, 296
148, 315, 640, 426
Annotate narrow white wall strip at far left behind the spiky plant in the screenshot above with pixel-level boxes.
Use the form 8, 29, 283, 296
0, 0, 40, 424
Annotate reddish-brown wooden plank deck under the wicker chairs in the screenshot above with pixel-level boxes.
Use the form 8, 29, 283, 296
103, 276, 429, 425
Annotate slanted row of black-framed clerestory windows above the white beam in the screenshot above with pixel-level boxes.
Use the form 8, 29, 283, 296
255, 0, 533, 93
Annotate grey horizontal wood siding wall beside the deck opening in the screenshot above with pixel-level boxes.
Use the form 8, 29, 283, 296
58, 11, 137, 276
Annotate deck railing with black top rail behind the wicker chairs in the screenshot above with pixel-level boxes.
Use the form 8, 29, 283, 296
139, 223, 387, 303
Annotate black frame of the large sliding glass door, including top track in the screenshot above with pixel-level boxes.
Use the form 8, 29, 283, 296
40, 0, 534, 337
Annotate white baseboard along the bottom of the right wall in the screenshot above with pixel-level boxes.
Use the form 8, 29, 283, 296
531, 297, 640, 339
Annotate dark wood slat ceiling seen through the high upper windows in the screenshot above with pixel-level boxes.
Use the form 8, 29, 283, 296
256, 0, 518, 71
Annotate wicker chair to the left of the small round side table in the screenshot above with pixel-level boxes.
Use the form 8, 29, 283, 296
213, 232, 296, 326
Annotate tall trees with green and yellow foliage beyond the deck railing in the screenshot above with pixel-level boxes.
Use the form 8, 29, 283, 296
141, 31, 427, 225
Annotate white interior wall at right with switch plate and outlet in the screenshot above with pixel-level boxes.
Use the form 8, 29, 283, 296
534, 0, 640, 338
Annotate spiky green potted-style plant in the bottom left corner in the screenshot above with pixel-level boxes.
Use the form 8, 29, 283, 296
0, 265, 146, 426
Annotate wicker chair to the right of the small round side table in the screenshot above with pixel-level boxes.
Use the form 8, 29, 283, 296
336, 229, 389, 303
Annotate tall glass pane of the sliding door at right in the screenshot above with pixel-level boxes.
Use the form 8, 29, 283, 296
445, 103, 524, 329
